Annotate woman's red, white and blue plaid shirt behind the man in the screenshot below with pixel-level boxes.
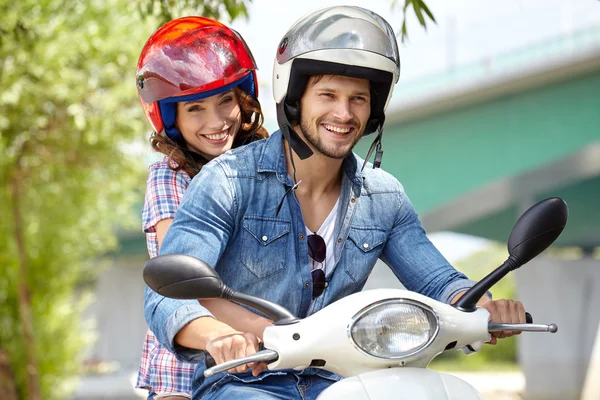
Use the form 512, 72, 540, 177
136, 157, 196, 398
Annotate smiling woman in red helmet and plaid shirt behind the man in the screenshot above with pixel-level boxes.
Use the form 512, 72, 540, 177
136, 17, 267, 399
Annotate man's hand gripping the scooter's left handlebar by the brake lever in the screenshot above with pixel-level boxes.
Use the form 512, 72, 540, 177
206, 332, 267, 376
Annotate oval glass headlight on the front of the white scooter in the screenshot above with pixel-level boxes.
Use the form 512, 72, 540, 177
349, 299, 439, 358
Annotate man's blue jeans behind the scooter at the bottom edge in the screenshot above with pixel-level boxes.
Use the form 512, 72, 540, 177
192, 370, 335, 400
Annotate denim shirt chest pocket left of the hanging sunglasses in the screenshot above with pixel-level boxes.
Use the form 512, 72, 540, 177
241, 217, 291, 278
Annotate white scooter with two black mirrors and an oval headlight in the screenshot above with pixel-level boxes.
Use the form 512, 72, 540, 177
144, 198, 568, 400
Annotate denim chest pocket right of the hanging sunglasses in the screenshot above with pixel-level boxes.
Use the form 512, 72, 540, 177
345, 227, 387, 283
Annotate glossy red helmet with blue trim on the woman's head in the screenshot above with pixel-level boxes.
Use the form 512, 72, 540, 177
137, 17, 258, 137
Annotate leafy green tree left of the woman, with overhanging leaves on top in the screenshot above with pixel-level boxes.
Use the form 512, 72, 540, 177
0, 0, 433, 400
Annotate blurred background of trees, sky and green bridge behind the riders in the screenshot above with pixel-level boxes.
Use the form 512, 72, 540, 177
0, 0, 600, 400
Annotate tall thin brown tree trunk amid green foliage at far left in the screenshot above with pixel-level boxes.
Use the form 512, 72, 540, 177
11, 178, 42, 400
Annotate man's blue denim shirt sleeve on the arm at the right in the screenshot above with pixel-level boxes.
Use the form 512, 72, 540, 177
381, 186, 475, 303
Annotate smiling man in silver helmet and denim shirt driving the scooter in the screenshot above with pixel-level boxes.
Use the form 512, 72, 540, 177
145, 7, 525, 399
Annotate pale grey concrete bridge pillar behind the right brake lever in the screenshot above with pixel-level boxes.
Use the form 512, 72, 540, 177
516, 255, 600, 400
